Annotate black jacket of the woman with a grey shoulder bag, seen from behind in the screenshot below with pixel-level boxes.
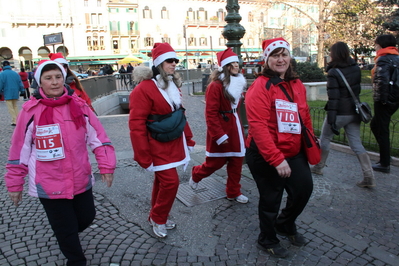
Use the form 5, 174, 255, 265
325, 59, 361, 124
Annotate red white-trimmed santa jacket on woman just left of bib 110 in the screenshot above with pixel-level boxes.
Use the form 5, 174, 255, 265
205, 81, 245, 157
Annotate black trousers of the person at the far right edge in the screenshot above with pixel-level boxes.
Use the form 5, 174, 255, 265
370, 102, 399, 166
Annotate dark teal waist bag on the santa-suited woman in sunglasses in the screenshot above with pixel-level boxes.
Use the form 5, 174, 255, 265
147, 107, 186, 142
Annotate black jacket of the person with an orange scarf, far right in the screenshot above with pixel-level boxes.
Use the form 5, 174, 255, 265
373, 54, 399, 103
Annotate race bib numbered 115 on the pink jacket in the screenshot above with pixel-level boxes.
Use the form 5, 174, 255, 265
35, 124, 65, 161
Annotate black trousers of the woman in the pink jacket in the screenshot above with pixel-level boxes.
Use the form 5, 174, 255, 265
40, 189, 96, 266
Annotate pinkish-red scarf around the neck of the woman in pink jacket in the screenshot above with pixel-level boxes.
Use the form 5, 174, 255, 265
39, 88, 86, 129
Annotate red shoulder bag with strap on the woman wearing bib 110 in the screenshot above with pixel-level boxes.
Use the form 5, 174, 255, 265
279, 84, 321, 165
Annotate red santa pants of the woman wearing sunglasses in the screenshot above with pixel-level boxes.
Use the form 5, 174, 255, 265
150, 168, 179, 224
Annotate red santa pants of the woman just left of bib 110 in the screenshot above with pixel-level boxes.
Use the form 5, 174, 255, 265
192, 157, 244, 198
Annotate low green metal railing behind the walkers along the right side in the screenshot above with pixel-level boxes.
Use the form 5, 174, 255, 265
310, 107, 399, 157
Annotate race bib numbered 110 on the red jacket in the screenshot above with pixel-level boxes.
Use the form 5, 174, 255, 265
276, 99, 301, 134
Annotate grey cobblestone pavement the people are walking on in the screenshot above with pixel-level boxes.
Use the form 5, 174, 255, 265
0, 93, 399, 266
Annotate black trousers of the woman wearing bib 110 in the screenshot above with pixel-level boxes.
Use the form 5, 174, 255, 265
245, 148, 313, 248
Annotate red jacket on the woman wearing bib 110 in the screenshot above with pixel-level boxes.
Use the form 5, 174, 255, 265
245, 76, 313, 167
